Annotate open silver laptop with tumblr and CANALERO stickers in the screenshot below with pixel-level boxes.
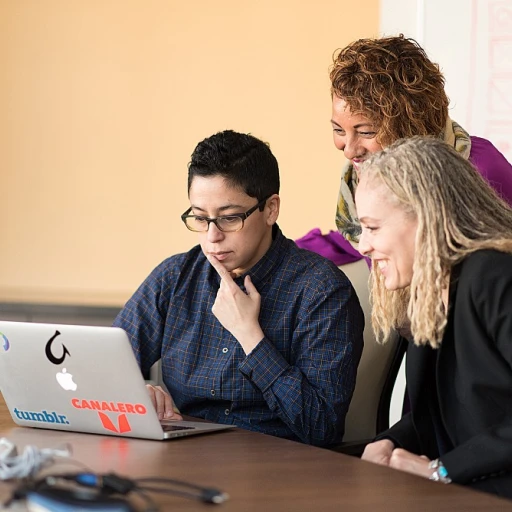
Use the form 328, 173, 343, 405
0, 321, 235, 439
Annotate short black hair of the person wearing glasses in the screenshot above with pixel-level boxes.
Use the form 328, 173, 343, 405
188, 130, 279, 201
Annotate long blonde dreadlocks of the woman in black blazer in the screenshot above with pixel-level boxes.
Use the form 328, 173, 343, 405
361, 137, 512, 348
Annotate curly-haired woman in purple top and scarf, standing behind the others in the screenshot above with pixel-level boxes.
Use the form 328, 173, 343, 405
330, 35, 512, 242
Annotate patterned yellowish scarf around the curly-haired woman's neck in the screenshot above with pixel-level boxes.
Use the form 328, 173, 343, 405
336, 118, 471, 244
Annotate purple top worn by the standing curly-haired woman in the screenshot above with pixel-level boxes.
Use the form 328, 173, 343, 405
295, 136, 512, 265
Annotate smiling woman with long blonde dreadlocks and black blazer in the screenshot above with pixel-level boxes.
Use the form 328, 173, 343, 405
355, 137, 512, 498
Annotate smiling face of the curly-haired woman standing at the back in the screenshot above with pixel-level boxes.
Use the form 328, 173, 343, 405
331, 95, 382, 171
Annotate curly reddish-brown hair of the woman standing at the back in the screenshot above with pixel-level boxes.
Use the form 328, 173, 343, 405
330, 34, 449, 146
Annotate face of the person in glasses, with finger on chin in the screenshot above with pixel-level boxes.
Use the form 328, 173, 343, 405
189, 176, 280, 275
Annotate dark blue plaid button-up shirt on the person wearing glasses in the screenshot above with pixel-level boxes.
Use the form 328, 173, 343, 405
114, 226, 364, 445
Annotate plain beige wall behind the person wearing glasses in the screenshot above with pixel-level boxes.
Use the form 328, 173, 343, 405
0, 0, 379, 305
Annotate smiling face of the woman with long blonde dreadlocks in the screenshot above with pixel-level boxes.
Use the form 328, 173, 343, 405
355, 173, 418, 290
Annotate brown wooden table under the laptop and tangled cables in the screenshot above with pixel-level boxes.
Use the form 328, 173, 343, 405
0, 395, 512, 512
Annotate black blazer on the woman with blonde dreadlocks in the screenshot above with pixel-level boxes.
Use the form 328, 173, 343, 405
377, 250, 512, 498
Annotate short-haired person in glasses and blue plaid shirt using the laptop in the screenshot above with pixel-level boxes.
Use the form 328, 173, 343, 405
115, 131, 364, 446
